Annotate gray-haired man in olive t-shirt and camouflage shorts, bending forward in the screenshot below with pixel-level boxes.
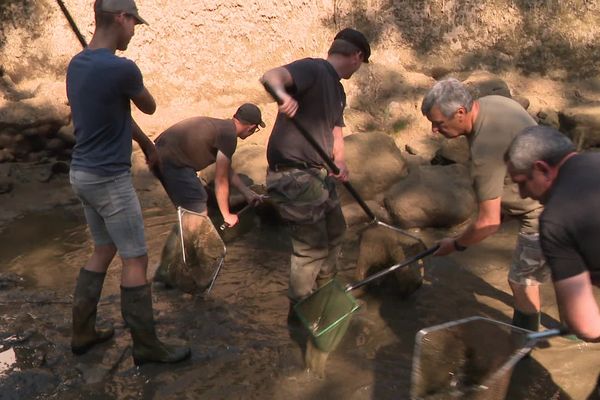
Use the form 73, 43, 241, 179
421, 78, 549, 331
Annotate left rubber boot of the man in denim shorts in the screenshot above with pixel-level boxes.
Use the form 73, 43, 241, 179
71, 268, 115, 355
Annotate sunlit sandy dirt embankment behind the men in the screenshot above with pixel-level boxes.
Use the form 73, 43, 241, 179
0, 0, 600, 225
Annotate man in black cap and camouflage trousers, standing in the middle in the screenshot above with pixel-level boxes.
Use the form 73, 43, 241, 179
261, 28, 371, 323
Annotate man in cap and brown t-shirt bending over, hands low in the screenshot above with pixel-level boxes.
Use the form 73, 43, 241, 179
154, 103, 265, 285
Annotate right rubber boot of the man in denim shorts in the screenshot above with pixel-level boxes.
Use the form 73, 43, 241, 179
121, 284, 190, 365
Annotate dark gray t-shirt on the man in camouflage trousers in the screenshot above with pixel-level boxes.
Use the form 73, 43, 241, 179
267, 58, 346, 167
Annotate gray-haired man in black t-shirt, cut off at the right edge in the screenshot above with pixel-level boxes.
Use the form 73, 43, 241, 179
505, 126, 600, 342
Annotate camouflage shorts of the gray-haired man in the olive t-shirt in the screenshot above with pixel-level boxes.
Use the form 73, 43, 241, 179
508, 233, 550, 286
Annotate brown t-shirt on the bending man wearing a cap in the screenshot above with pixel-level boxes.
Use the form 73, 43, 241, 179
155, 117, 237, 171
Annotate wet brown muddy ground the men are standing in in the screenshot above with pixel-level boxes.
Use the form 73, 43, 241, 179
0, 208, 600, 400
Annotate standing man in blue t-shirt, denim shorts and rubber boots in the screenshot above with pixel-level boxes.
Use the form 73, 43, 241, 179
67, 0, 190, 364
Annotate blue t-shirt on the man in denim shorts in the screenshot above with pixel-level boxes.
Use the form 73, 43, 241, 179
67, 49, 144, 176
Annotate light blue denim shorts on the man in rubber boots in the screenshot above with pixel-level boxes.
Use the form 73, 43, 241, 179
70, 169, 147, 258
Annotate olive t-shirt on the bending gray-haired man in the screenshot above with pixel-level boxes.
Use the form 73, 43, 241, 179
467, 96, 542, 233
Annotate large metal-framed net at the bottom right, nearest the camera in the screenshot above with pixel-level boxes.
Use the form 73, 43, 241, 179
411, 317, 565, 400
